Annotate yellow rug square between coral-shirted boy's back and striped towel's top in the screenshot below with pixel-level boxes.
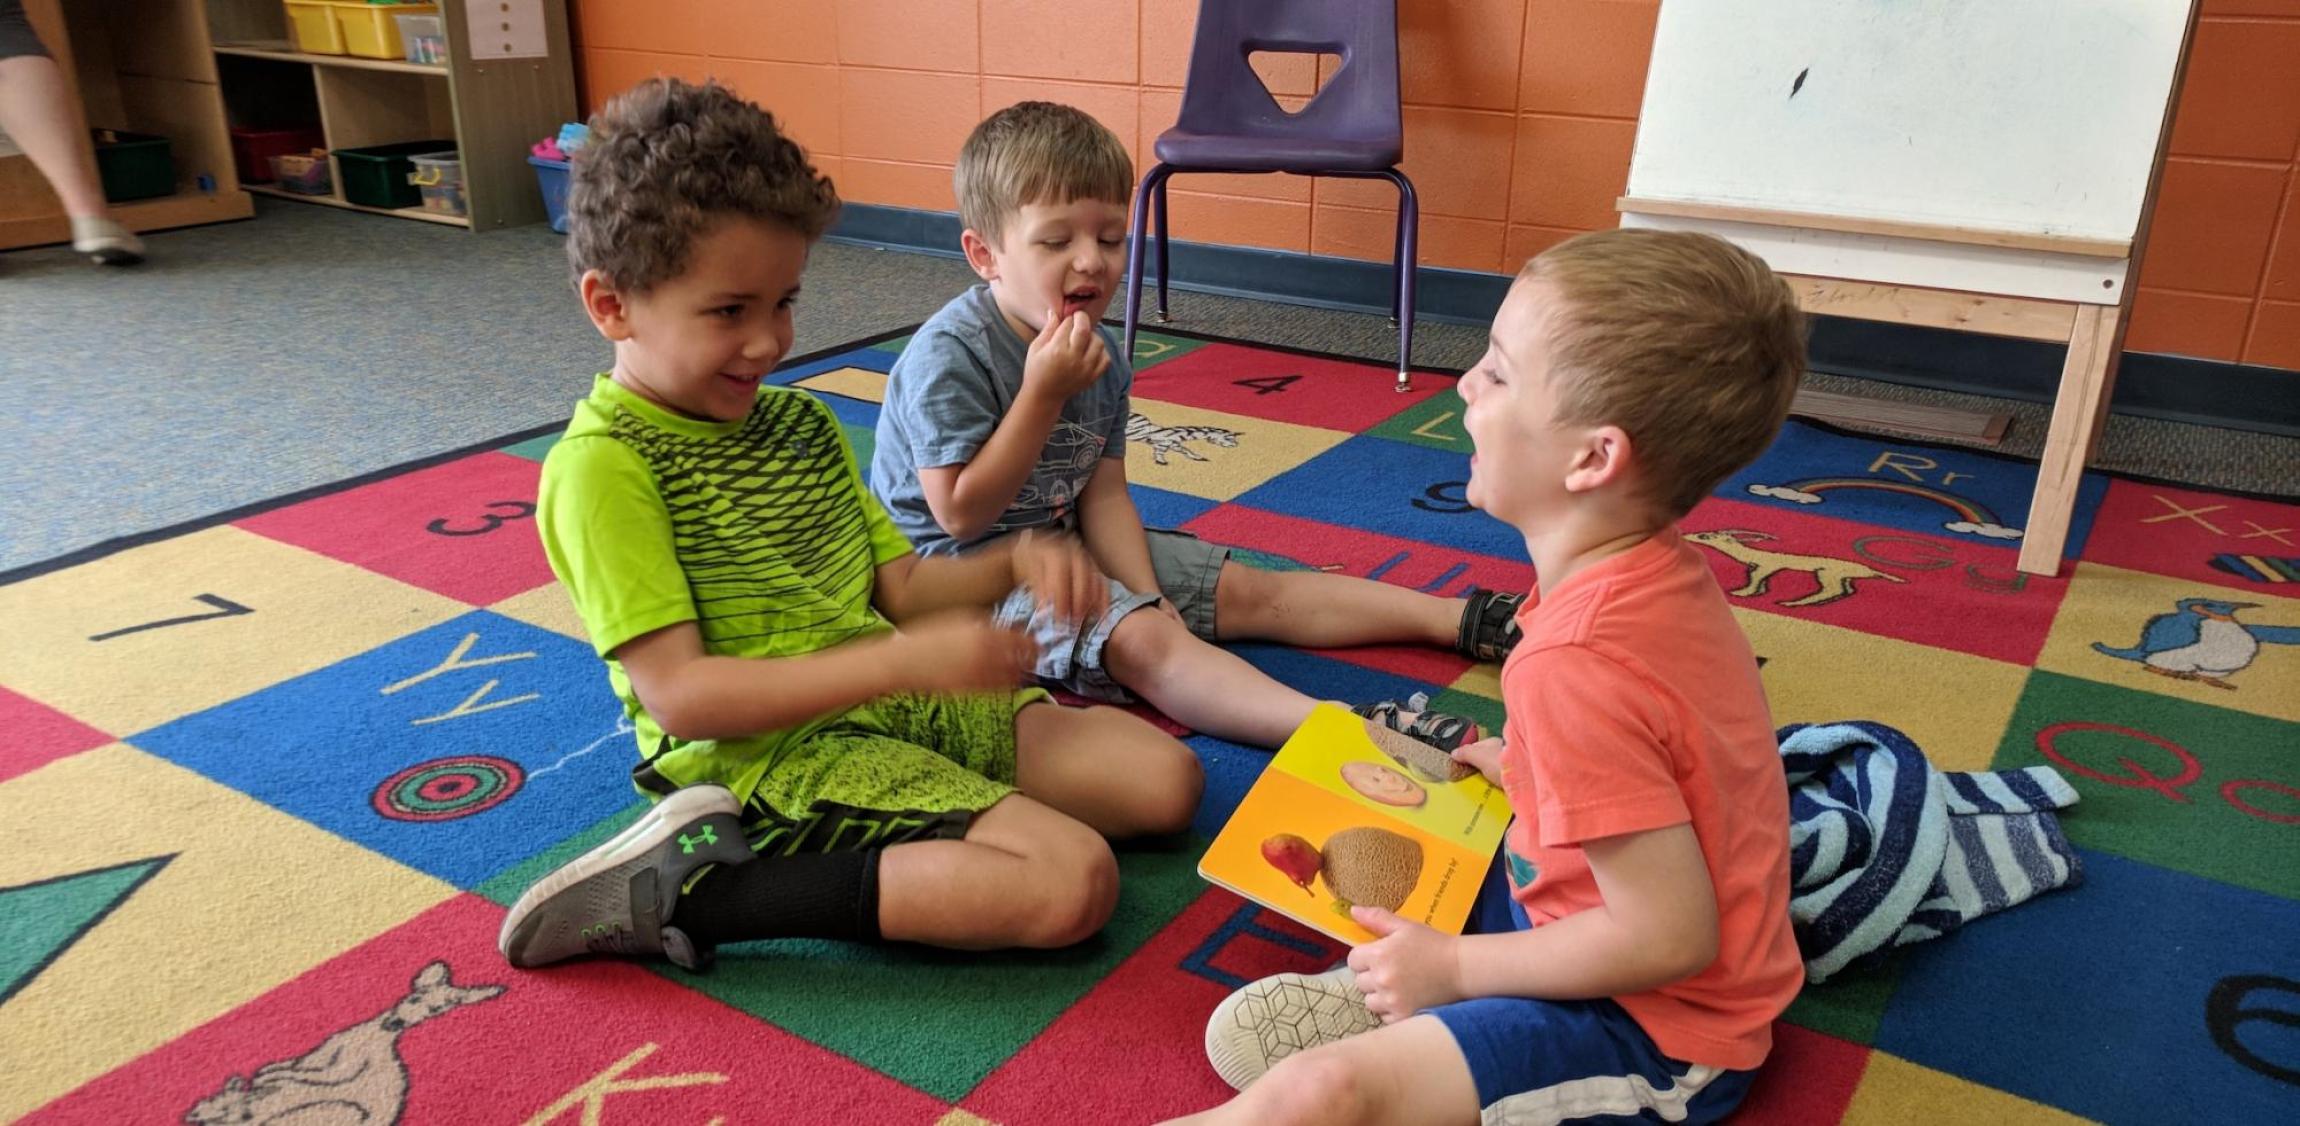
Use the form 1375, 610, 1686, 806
1734, 609, 2029, 770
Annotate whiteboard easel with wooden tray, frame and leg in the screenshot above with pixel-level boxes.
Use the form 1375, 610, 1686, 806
1619, 0, 2194, 574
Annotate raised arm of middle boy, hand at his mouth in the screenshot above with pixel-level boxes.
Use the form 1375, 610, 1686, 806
918, 313, 1111, 540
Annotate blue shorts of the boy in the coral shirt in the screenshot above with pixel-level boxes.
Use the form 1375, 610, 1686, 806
1428, 855, 1757, 1126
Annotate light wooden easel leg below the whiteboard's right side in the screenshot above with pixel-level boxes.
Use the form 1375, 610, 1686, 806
2019, 306, 2123, 574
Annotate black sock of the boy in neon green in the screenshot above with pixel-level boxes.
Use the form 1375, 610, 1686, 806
672, 848, 881, 947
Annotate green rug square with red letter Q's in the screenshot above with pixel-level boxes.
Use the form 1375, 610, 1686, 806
1994, 669, 2300, 899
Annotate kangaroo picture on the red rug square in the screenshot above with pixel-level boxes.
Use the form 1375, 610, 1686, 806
184, 961, 504, 1126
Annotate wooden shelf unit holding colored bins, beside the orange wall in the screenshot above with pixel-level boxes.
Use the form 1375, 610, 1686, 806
207, 0, 577, 230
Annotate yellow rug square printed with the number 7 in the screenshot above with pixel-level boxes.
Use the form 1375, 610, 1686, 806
0, 526, 469, 735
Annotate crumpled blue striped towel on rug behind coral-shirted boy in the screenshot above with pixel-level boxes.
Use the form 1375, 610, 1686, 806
1780, 722, 2084, 984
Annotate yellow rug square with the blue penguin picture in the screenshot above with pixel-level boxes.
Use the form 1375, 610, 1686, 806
2036, 563, 2300, 722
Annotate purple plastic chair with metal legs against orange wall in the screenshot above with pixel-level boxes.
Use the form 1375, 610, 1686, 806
1127, 0, 1421, 391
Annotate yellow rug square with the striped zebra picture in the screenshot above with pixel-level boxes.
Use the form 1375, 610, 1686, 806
1127, 400, 1350, 501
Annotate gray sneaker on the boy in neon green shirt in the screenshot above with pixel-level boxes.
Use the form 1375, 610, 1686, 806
497, 786, 752, 970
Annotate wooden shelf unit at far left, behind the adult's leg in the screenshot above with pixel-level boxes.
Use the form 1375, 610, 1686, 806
0, 0, 255, 250
